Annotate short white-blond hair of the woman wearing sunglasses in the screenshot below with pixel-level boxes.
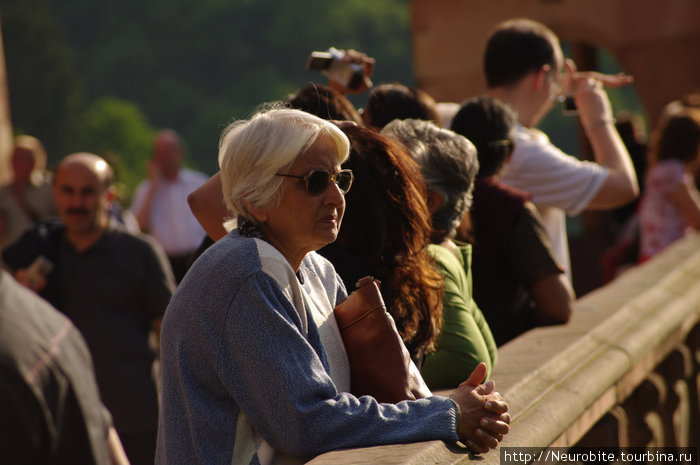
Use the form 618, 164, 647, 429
219, 103, 350, 230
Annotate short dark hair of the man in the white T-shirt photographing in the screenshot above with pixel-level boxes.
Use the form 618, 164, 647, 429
484, 18, 559, 88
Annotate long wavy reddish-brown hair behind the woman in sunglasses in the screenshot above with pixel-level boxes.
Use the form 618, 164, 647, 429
338, 127, 443, 353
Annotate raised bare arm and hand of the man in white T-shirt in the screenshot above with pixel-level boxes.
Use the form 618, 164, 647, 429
567, 62, 639, 209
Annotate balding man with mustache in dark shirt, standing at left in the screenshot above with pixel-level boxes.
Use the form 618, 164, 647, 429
3, 153, 175, 464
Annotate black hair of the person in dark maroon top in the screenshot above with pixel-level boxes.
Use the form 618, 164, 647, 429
451, 95, 517, 178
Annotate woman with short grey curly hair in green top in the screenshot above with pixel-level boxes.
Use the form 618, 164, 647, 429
382, 119, 496, 389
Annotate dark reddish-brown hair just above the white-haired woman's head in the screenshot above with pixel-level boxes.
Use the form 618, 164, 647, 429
284, 84, 362, 125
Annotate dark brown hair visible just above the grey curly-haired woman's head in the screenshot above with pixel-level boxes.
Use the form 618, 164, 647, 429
363, 82, 441, 130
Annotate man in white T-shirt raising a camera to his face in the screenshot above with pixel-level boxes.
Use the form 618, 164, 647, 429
484, 19, 639, 279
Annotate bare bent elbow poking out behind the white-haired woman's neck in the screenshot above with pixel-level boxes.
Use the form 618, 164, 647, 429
187, 173, 231, 241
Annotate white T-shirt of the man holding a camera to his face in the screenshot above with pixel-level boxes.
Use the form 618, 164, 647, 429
501, 124, 608, 280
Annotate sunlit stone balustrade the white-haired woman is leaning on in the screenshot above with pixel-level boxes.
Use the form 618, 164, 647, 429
309, 234, 700, 465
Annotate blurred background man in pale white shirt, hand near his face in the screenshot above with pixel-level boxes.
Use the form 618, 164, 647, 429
131, 129, 208, 283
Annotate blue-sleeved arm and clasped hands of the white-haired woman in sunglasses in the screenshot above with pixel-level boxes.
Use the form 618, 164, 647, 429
212, 276, 504, 457
